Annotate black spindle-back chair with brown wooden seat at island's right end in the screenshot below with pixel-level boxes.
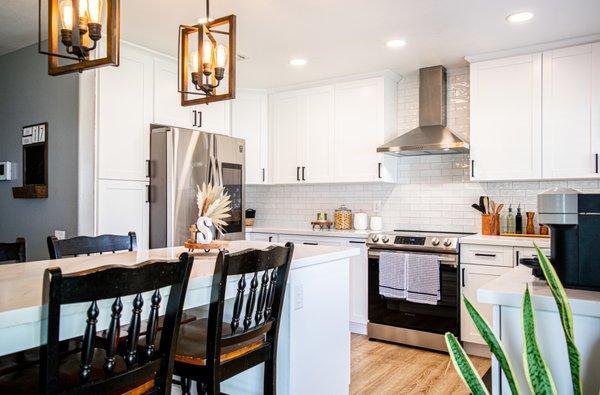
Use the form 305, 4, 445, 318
166, 243, 294, 394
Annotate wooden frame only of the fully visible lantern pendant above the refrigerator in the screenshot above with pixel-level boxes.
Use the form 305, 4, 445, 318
178, 15, 237, 107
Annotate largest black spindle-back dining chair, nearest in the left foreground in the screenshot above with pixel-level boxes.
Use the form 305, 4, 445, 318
0, 253, 194, 394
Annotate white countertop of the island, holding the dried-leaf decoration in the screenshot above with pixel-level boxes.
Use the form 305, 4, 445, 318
0, 240, 359, 318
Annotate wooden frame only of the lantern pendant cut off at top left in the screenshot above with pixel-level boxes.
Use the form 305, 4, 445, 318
38, 0, 121, 75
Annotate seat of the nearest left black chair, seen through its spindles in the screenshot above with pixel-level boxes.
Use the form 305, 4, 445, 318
0, 349, 154, 395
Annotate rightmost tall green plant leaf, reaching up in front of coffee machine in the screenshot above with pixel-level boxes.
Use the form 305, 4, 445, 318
534, 244, 583, 395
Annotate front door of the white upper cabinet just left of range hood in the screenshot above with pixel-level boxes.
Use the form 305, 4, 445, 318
333, 79, 384, 182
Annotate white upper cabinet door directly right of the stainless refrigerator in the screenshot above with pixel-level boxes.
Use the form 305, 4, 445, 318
231, 92, 268, 184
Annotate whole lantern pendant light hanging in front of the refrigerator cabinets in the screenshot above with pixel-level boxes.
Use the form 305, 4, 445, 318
178, 0, 236, 106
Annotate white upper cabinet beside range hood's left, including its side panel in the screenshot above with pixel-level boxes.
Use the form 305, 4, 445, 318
333, 77, 398, 182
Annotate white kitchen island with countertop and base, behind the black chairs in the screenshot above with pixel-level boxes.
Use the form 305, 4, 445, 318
0, 241, 359, 394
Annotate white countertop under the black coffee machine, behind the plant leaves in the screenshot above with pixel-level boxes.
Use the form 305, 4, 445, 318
477, 266, 600, 317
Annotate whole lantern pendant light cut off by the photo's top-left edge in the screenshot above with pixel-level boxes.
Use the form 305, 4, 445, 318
38, 0, 120, 75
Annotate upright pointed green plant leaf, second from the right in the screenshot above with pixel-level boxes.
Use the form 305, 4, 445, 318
523, 286, 556, 395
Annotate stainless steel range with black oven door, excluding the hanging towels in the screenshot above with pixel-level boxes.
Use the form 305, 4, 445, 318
367, 231, 465, 351
